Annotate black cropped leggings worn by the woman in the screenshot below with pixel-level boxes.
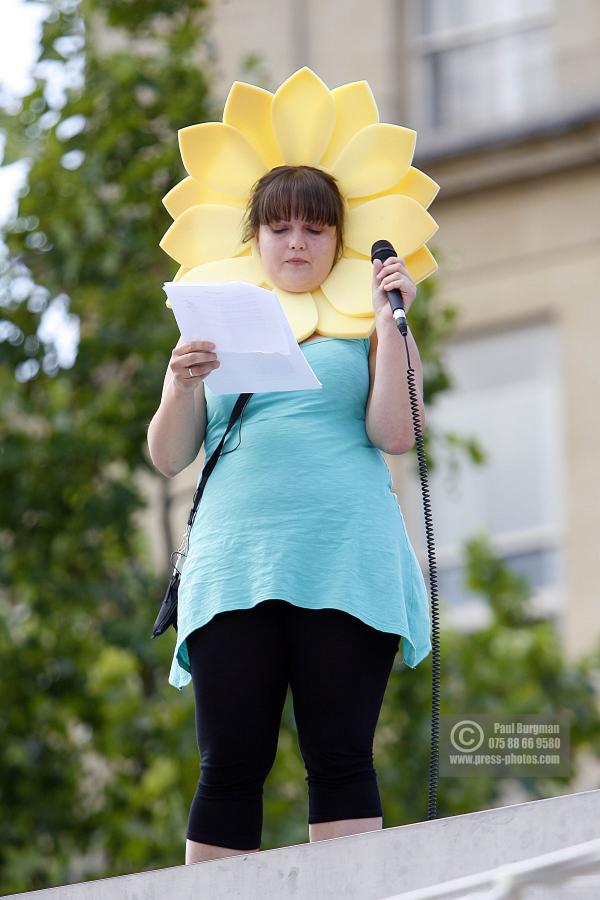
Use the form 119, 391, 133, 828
187, 600, 400, 850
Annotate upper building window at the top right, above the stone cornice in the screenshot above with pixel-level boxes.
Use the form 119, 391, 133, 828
409, 0, 555, 139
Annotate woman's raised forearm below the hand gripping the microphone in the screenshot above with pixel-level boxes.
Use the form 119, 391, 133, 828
366, 316, 425, 454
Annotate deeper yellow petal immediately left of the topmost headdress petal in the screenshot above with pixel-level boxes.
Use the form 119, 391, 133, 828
223, 81, 283, 169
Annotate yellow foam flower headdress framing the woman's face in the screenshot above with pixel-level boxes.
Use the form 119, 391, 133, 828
160, 67, 439, 341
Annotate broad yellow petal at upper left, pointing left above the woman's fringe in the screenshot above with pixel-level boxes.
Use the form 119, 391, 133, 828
178, 122, 267, 200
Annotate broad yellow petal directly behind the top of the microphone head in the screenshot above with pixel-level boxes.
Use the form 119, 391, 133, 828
344, 194, 438, 259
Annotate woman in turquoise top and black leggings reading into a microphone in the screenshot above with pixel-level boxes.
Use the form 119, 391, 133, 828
148, 166, 431, 863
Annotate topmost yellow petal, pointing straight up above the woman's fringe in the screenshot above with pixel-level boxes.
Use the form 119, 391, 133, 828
272, 66, 335, 166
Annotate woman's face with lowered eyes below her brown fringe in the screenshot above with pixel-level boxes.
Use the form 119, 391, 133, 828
256, 219, 337, 293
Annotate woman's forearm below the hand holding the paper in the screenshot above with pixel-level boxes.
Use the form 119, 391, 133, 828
148, 380, 206, 478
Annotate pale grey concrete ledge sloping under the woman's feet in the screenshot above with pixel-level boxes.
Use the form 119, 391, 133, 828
10, 790, 600, 900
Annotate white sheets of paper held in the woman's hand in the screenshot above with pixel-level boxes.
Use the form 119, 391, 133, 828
163, 281, 323, 394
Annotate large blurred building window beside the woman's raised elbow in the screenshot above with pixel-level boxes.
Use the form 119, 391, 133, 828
409, 323, 563, 622
